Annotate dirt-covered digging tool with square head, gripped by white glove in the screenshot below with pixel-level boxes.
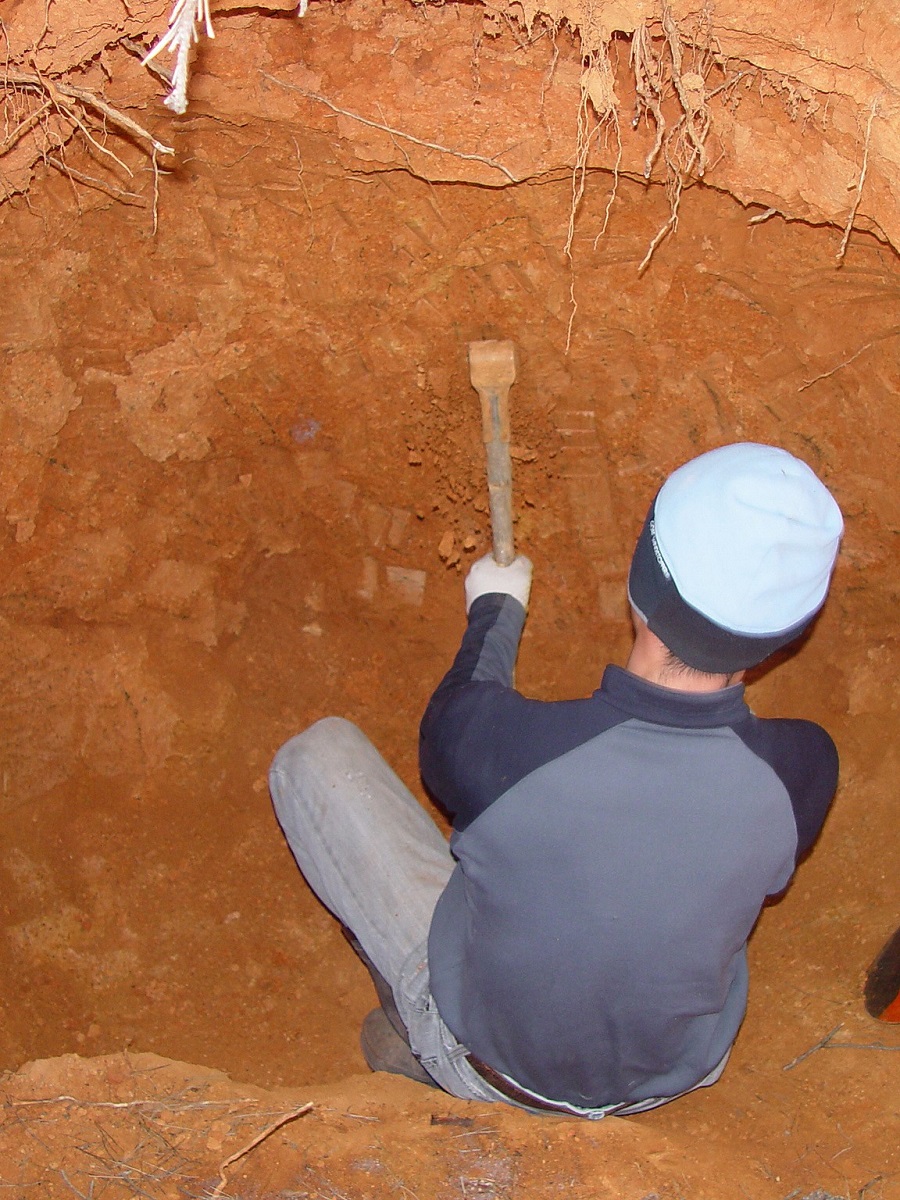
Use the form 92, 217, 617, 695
469, 341, 518, 566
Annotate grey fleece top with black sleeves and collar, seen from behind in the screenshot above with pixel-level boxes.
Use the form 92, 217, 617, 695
420, 594, 838, 1108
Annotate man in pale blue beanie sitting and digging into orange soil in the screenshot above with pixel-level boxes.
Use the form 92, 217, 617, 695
271, 443, 842, 1118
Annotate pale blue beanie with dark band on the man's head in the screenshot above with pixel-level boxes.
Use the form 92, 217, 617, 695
629, 442, 844, 673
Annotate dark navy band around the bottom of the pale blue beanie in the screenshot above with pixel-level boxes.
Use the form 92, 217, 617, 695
628, 502, 812, 674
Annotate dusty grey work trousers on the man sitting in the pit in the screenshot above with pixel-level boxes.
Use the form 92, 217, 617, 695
269, 716, 727, 1120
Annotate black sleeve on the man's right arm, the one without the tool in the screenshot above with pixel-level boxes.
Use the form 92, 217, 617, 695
734, 716, 838, 862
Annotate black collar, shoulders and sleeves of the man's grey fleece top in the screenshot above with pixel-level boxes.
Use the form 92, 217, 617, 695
419, 593, 838, 857
